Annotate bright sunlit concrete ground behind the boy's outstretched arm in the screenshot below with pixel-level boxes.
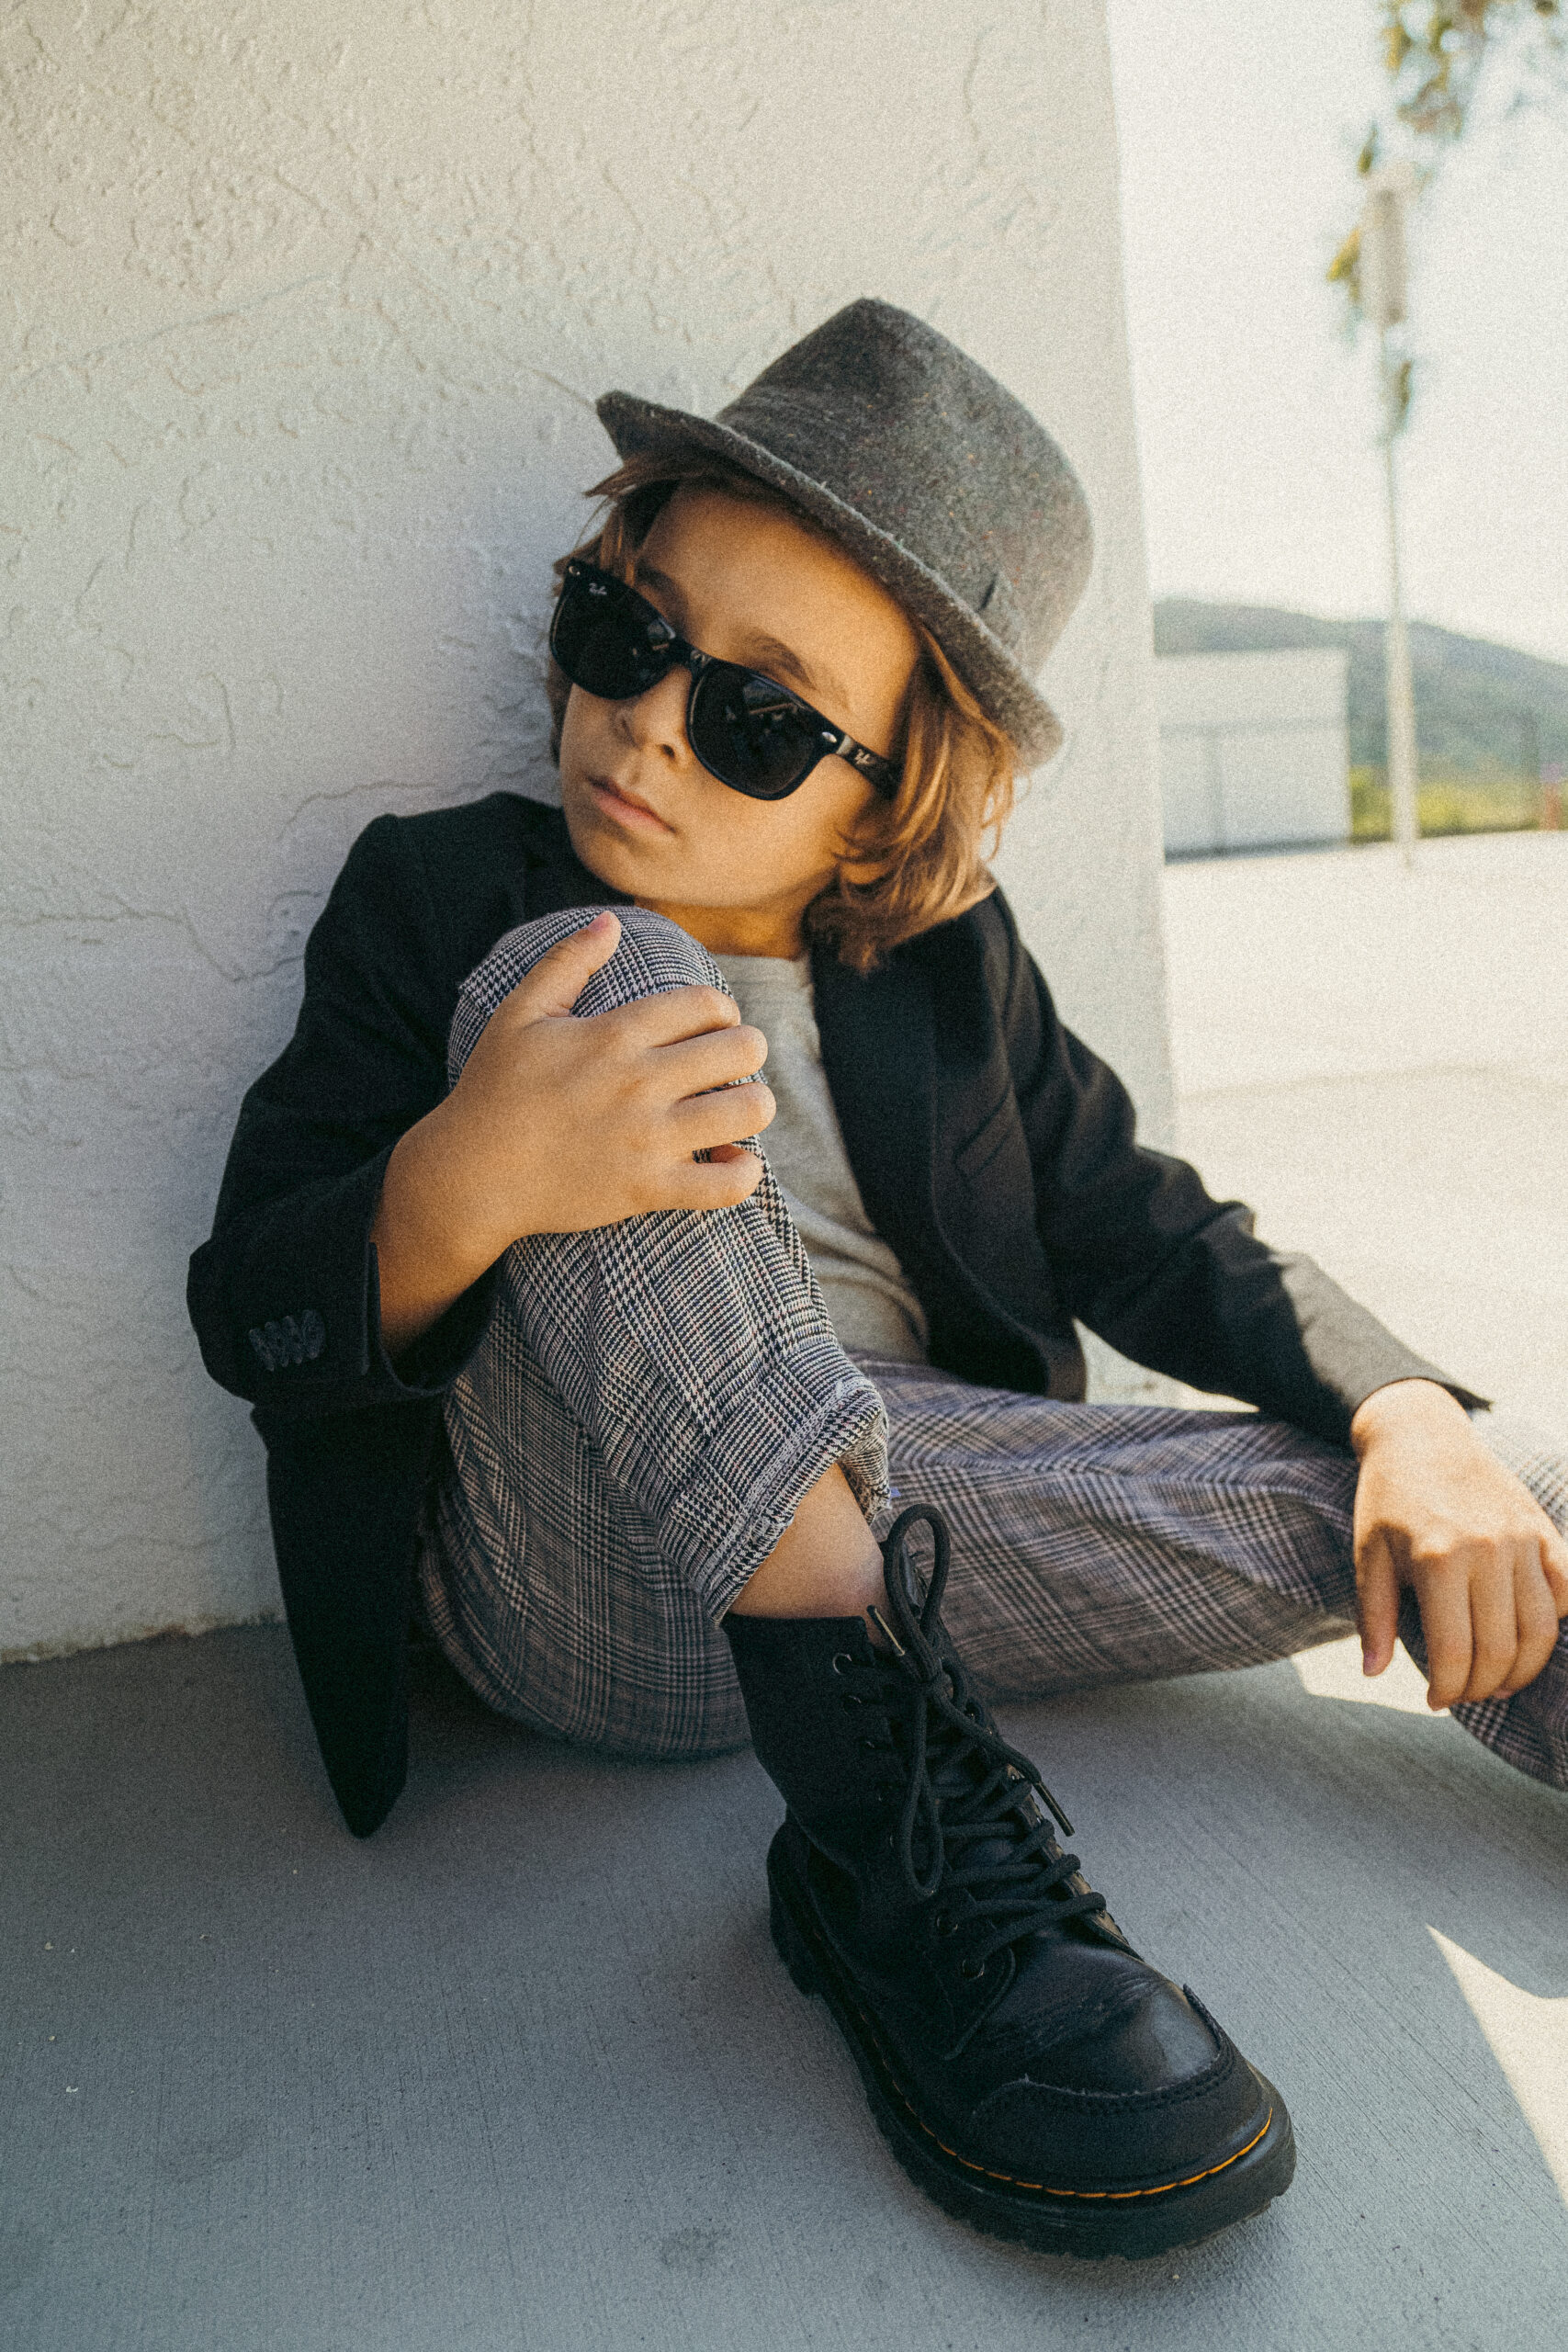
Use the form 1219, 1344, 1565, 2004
1166, 832, 1568, 1437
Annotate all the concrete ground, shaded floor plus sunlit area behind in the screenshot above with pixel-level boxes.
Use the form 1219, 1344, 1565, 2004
0, 842, 1568, 2352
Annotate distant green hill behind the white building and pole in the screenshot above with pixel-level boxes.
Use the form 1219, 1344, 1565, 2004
1155, 597, 1568, 776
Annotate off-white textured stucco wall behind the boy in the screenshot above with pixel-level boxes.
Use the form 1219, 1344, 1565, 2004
0, 0, 1168, 1654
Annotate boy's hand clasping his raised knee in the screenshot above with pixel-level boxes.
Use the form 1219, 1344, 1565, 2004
445, 910, 773, 1263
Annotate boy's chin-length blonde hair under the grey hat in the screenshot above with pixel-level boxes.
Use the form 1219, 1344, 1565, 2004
546, 447, 1016, 971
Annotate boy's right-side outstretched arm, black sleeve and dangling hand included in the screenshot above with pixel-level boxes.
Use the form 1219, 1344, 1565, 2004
991, 898, 1568, 1708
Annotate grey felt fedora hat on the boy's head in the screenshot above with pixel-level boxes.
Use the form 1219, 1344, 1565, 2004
597, 301, 1093, 767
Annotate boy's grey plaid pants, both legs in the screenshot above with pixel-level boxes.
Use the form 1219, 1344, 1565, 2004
421, 908, 1568, 1788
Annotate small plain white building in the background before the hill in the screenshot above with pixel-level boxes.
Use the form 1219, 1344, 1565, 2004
1155, 647, 1349, 856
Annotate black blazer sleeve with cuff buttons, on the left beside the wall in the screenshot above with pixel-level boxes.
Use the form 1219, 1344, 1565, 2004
186, 816, 493, 1425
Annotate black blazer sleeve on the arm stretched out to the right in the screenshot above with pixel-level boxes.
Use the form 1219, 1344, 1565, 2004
999, 908, 1488, 1444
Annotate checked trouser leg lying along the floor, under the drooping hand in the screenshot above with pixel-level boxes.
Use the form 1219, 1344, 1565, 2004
861, 1357, 1568, 1788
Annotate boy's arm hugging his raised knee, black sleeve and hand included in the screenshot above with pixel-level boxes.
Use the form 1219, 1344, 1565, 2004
188, 819, 773, 1420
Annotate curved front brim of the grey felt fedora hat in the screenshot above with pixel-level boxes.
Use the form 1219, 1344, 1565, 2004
594, 393, 1063, 767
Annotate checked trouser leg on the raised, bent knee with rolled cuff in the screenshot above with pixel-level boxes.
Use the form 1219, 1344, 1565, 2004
421, 906, 886, 1755
